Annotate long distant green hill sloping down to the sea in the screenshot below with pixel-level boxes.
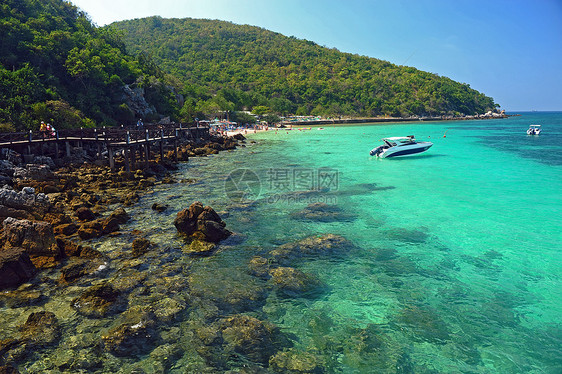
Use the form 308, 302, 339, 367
112, 17, 497, 117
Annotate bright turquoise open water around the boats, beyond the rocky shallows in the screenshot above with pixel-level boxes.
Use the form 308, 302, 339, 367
189, 113, 562, 373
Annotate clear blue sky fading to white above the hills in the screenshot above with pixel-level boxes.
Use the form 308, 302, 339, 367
71, 0, 562, 111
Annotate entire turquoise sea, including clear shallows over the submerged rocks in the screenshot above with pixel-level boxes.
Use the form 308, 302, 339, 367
3, 112, 562, 373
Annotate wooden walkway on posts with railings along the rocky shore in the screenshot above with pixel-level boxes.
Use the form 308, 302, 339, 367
0, 124, 210, 171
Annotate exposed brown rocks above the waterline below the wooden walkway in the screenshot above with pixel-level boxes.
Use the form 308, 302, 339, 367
0, 136, 266, 373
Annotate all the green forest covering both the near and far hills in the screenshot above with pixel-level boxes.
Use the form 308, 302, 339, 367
0, 0, 496, 131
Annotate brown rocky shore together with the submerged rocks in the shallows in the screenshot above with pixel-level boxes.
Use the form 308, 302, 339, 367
0, 129, 365, 373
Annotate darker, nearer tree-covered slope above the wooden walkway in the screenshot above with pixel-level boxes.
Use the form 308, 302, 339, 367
0, 0, 177, 131
